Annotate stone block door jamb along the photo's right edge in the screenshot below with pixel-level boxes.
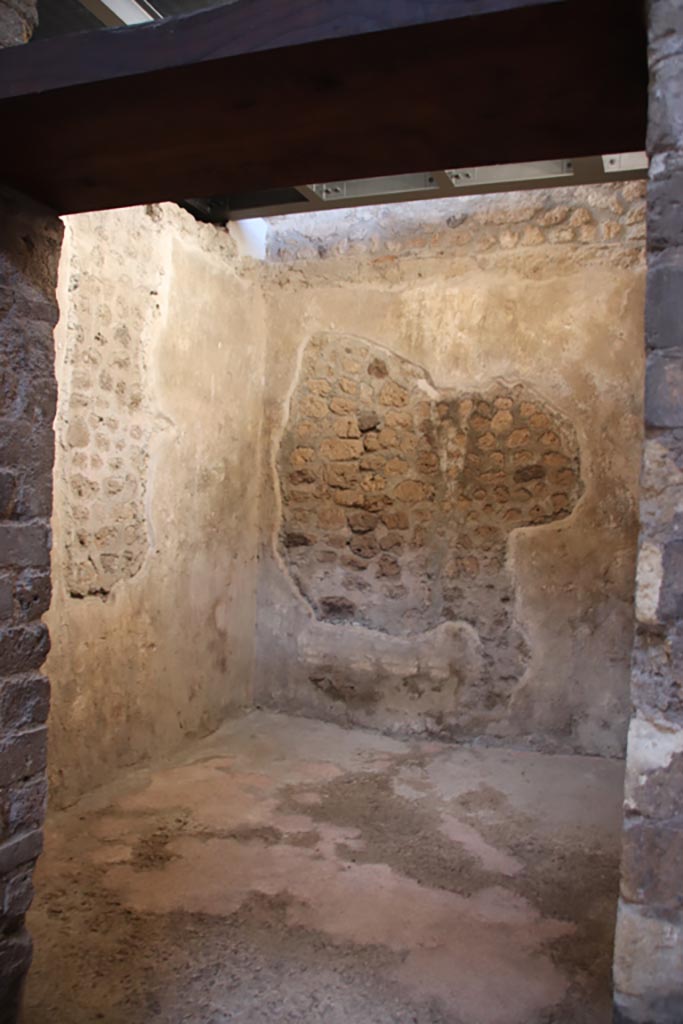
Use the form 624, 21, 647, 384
614, 0, 683, 1024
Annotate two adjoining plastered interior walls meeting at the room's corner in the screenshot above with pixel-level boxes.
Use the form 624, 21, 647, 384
47, 183, 644, 805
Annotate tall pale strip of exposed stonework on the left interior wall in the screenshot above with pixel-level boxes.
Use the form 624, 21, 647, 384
57, 214, 154, 597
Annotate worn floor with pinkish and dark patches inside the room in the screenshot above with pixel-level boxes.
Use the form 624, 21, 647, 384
25, 712, 623, 1024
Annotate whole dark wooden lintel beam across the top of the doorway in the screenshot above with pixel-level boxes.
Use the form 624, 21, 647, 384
0, 0, 646, 213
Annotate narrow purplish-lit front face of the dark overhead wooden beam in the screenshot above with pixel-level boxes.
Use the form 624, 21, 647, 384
0, 0, 562, 98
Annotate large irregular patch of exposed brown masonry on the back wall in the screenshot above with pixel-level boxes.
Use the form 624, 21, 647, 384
278, 335, 583, 733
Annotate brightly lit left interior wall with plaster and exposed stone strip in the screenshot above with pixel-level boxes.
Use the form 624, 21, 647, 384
47, 206, 264, 806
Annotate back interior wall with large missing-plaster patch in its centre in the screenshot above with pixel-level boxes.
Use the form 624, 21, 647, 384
255, 183, 644, 754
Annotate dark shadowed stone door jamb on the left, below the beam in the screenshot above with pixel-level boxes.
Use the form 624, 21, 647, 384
0, 194, 61, 1024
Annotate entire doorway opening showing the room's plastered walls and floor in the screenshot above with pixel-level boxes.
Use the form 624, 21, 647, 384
27, 181, 644, 1024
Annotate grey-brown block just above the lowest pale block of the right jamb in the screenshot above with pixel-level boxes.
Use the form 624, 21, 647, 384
622, 820, 683, 911
